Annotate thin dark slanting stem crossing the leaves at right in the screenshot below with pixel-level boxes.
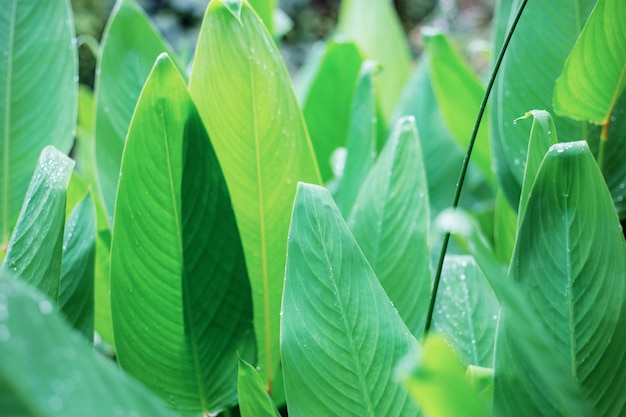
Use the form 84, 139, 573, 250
424, 0, 528, 336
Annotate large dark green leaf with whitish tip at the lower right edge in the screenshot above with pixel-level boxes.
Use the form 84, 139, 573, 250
494, 141, 626, 416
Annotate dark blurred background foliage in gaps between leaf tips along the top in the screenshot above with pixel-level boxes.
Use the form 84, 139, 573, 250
71, 0, 496, 86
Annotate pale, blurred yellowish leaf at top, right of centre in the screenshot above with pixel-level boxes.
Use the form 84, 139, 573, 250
337, 0, 411, 120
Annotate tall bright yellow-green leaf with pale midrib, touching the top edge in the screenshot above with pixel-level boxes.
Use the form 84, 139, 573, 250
189, 0, 320, 392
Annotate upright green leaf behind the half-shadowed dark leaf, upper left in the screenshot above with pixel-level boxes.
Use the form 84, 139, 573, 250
95, 0, 184, 221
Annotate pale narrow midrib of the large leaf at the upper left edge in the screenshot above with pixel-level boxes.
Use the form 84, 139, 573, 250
0, 0, 17, 247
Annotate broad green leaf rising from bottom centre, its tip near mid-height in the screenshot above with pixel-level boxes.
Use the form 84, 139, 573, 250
281, 184, 417, 417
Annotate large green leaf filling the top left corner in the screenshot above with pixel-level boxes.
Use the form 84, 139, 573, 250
0, 0, 78, 247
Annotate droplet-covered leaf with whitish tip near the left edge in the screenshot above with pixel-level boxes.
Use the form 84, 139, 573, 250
2, 146, 74, 303
